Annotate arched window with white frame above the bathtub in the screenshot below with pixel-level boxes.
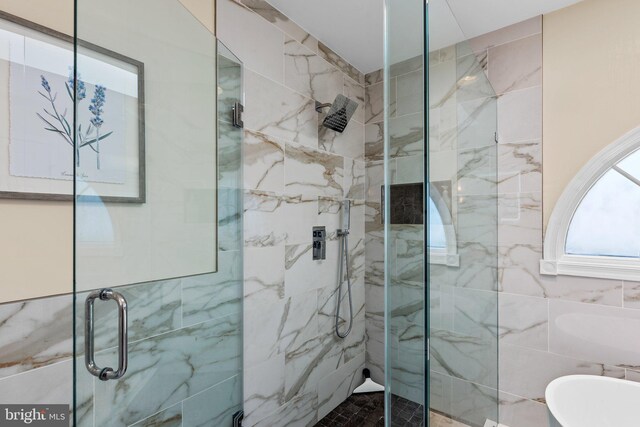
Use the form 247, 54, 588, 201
540, 128, 640, 280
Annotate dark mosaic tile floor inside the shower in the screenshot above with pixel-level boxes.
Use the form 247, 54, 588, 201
316, 393, 424, 427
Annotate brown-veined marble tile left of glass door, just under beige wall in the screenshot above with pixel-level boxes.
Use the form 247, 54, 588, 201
0, 295, 73, 377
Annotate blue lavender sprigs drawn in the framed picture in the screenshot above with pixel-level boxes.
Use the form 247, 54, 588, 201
36, 68, 113, 170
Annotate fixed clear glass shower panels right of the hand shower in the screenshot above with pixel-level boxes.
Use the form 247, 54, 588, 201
384, 0, 499, 426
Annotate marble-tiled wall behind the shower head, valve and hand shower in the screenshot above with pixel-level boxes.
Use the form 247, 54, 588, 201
218, 0, 368, 427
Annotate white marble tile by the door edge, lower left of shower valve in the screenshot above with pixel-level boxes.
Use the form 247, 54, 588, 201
244, 245, 284, 310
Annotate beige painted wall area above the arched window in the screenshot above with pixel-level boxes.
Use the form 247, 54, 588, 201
543, 0, 640, 228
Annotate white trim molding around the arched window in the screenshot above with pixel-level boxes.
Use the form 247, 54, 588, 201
540, 127, 640, 281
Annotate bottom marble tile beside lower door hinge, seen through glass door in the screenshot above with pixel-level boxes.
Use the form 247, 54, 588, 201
182, 374, 243, 427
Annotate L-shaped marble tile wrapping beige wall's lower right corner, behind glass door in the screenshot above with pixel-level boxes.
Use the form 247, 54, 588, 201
181, 251, 243, 326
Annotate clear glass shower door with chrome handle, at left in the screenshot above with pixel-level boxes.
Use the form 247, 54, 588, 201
74, 0, 242, 427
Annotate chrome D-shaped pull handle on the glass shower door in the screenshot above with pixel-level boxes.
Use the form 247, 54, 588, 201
84, 289, 129, 381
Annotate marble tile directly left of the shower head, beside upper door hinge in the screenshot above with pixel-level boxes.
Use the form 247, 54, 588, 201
245, 70, 318, 148
